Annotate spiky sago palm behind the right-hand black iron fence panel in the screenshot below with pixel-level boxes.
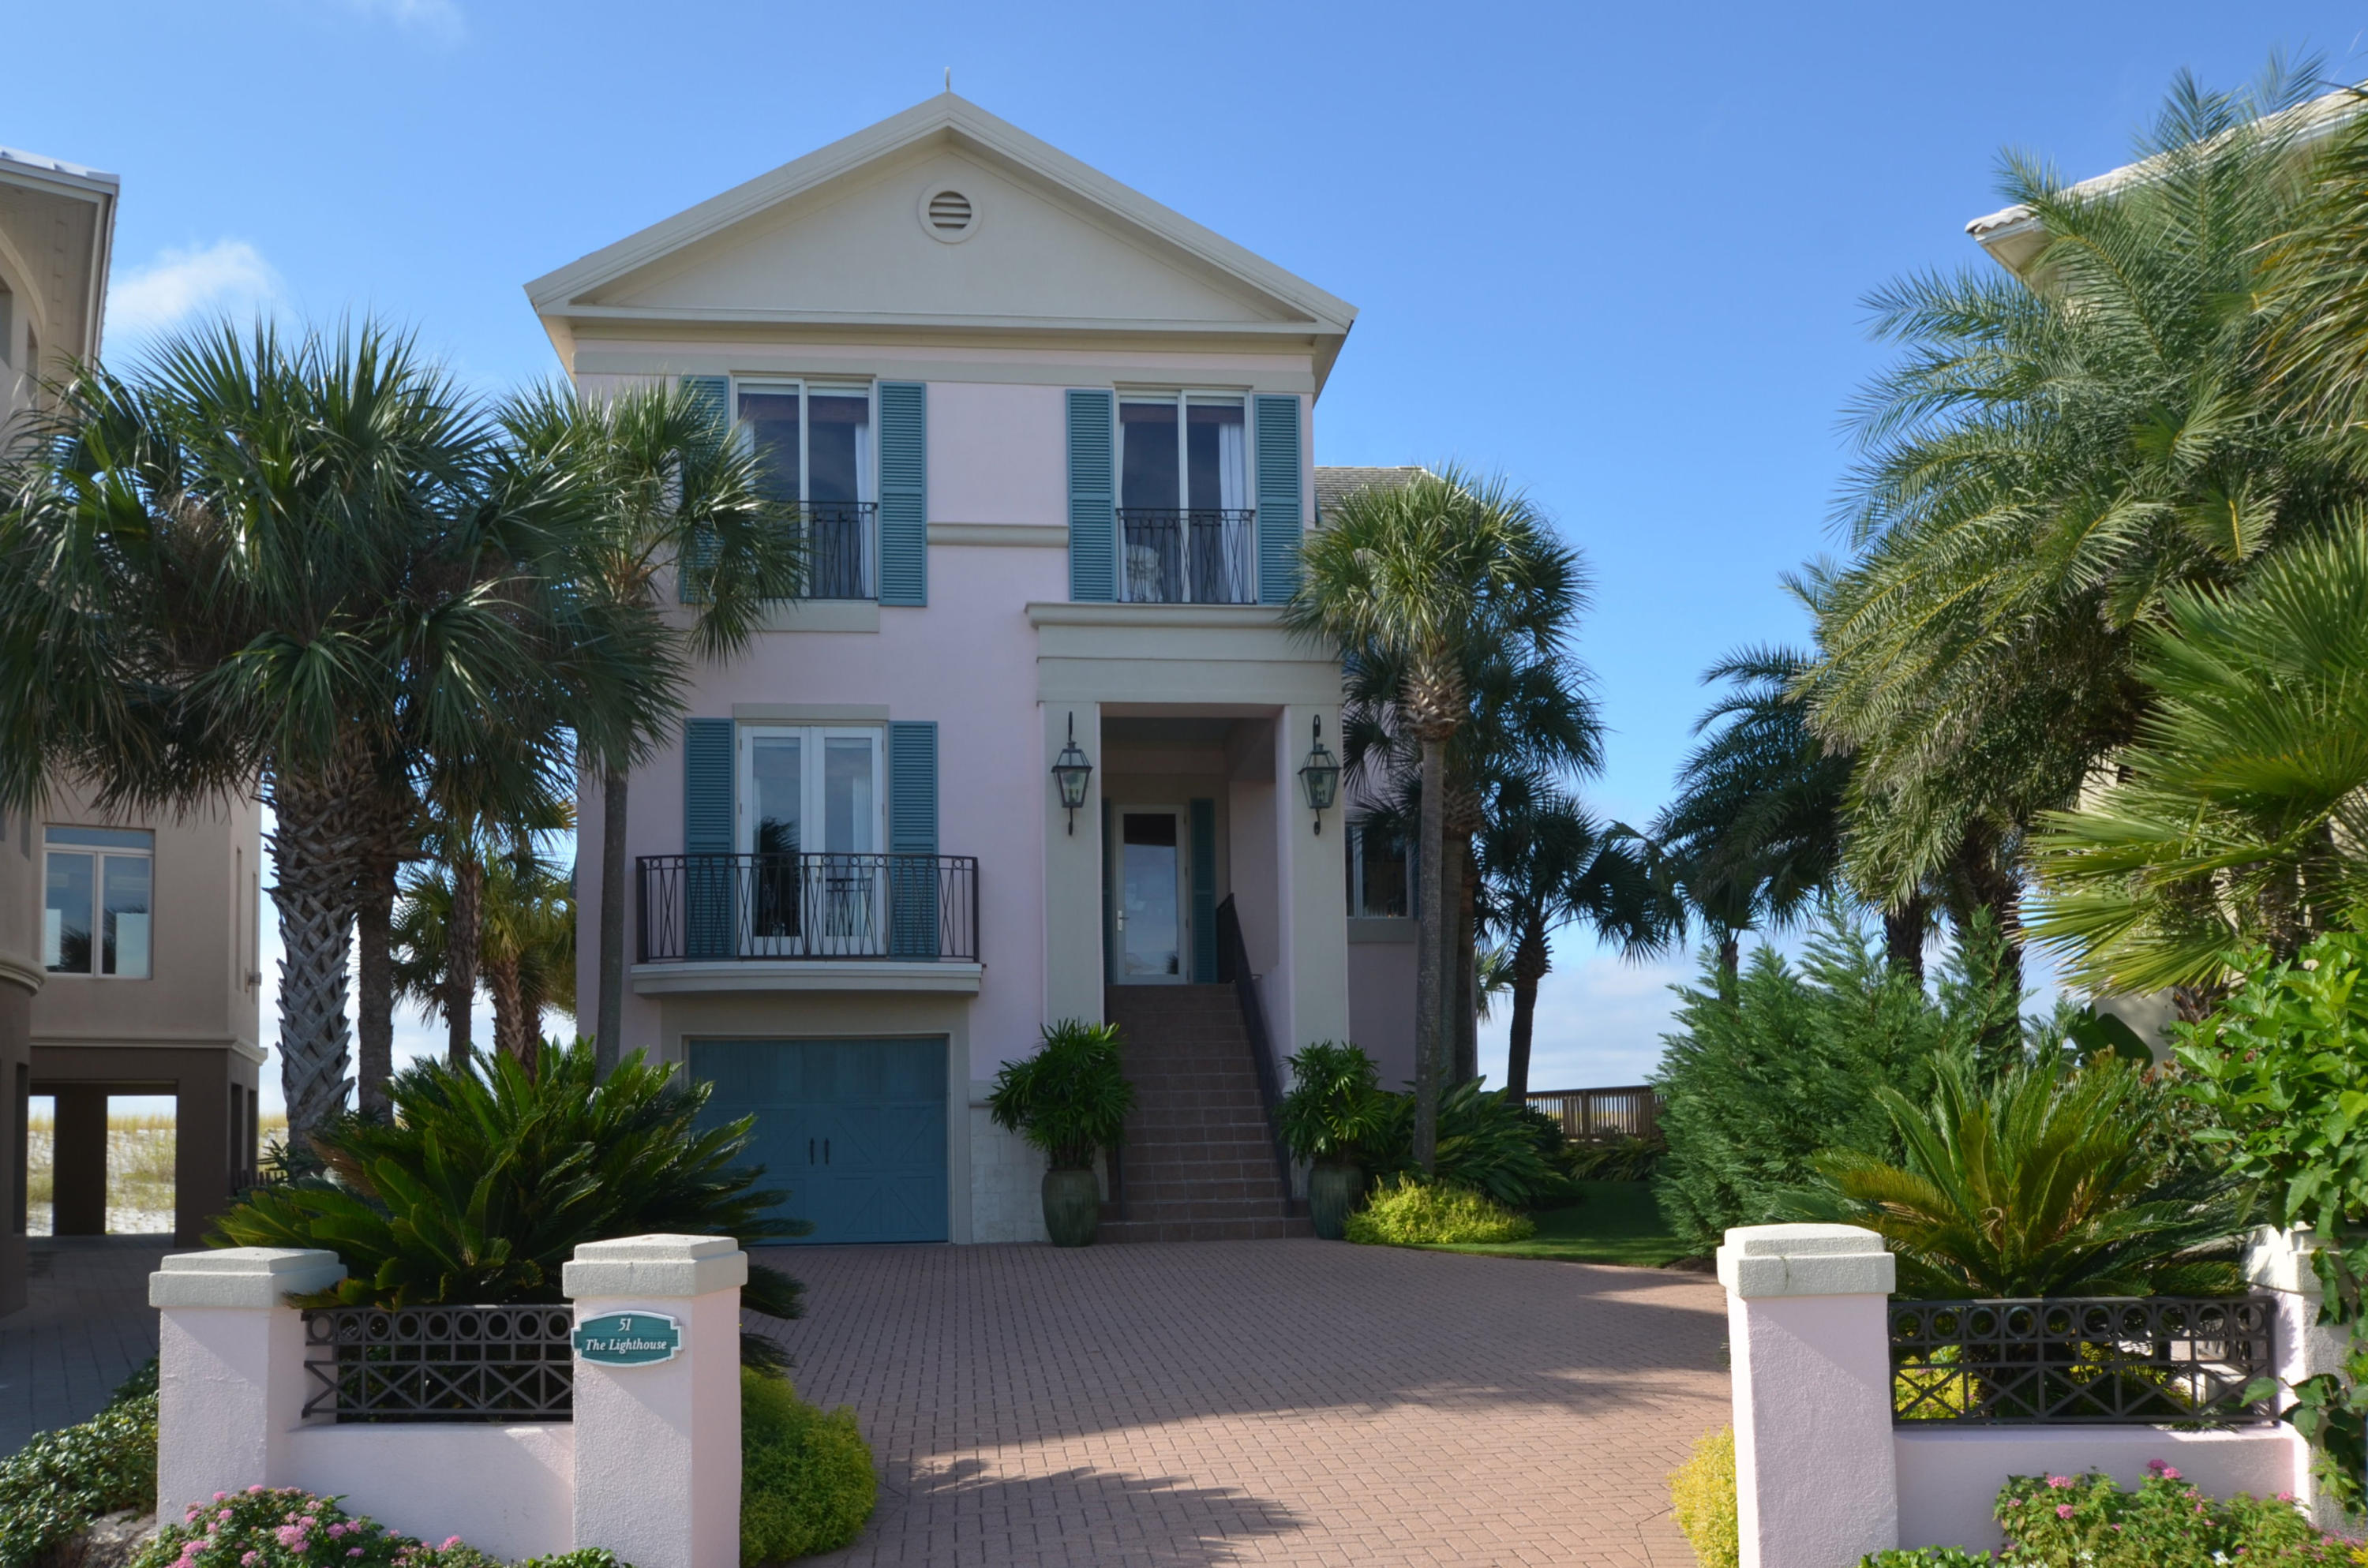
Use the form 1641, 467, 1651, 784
1790, 1057, 2252, 1298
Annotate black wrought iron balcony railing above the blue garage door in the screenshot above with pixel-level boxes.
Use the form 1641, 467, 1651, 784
639, 853, 978, 964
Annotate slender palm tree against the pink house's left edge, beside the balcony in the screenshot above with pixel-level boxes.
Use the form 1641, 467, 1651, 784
502, 384, 805, 1073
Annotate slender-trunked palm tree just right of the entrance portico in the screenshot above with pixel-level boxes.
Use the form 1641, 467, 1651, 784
1283, 469, 1579, 1170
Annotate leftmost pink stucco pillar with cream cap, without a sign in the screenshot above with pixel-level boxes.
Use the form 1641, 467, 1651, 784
149, 1246, 346, 1525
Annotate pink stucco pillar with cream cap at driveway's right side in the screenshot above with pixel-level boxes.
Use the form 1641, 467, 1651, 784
1719, 1225, 1899, 1568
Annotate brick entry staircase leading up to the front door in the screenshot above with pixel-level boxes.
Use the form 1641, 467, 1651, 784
1099, 986, 1317, 1241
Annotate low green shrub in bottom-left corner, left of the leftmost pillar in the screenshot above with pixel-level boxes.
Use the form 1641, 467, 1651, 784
0, 1362, 156, 1568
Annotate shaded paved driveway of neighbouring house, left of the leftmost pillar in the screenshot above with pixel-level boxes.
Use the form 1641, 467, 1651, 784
0, 1237, 173, 1454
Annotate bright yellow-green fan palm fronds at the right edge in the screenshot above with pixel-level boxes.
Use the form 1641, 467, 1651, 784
2032, 523, 2368, 999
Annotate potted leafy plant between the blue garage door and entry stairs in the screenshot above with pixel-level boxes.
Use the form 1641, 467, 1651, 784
987, 1019, 1134, 1246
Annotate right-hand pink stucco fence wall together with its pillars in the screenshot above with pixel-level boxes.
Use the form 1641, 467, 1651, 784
1719, 1225, 2344, 1568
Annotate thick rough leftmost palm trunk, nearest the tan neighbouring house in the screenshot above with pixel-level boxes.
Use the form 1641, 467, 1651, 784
272, 779, 362, 1142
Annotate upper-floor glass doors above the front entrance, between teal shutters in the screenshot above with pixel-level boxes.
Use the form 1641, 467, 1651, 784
1115, 393, 1257, 604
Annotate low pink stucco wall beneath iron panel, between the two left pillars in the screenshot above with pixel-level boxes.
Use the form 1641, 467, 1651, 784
282, 1421, 575, 1561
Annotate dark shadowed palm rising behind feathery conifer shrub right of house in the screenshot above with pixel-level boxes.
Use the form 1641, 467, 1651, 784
1650, 649, 1847, 986
